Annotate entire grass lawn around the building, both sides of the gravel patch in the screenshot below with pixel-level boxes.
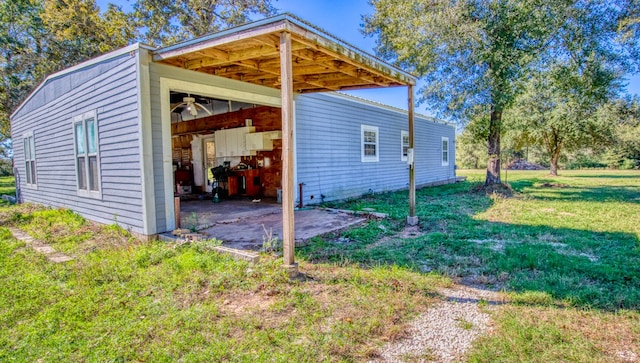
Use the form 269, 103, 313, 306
0, 171, 640, 362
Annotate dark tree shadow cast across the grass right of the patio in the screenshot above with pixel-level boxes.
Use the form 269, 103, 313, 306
299, 181, 640, 310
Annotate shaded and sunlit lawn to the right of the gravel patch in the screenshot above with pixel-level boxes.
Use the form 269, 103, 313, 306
301, 170, 640, 362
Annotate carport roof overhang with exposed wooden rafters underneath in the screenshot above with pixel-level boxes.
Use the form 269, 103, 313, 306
153, 14, 416, 93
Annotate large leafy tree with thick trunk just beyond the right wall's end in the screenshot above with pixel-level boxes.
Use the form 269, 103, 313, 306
364, 0, 634, 186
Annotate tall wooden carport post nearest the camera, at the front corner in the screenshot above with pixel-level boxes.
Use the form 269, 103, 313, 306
280, 32, 298, 277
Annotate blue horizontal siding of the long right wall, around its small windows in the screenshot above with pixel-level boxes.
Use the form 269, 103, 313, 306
295, 94, 455, 204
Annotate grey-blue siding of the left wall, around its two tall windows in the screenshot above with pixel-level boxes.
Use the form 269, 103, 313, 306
12, 53, 144, 233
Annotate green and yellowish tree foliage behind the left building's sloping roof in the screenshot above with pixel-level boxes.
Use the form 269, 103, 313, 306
0, 0, 275, 156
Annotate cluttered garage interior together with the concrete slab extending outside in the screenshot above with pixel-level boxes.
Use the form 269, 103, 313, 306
170, 91, 364, 250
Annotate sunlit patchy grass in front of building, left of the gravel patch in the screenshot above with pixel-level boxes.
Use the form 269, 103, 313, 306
0, 205, 449, 362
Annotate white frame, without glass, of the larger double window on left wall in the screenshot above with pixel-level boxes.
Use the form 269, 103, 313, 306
71, 111, 102, 199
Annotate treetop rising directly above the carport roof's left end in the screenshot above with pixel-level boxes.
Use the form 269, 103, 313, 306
133, 0, 275, 45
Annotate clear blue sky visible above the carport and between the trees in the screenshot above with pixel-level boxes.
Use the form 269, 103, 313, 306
97, 0, 640, 113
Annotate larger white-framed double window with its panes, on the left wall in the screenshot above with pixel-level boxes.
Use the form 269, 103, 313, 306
73, 111, 100, 197
